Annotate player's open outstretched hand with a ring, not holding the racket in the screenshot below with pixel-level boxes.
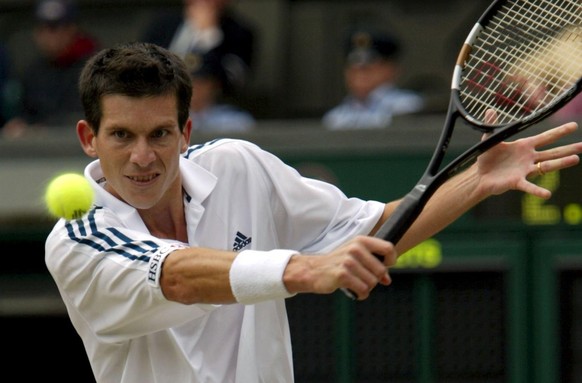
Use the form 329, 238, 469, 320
477, 122, 582, 199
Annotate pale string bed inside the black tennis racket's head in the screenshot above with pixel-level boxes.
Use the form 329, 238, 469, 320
459, 0, 582, 124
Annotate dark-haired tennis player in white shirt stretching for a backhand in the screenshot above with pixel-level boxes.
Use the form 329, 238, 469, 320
46, 43, 582, 383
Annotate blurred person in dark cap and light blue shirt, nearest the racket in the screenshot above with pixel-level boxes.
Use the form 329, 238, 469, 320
322, 30, 424, 130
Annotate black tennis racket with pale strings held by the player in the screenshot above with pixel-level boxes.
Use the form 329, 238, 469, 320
344, 0, 582, 297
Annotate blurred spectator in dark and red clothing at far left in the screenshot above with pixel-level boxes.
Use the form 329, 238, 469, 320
3, 0, 98, 137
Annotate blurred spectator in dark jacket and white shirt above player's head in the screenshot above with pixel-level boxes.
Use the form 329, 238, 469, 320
142, 0, 255, 99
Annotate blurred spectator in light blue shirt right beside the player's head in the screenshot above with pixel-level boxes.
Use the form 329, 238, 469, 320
190, 52, 255, 132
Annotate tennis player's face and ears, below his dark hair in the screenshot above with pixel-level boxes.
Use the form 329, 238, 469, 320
77, 95, 191, 209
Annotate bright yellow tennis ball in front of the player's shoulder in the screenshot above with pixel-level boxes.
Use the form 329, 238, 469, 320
45, 173, 94, 220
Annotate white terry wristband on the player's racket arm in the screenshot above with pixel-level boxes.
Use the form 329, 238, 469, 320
229, 249, 297, 305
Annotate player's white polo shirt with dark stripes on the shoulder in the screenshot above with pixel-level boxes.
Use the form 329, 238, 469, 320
45, 139, 384, 383
